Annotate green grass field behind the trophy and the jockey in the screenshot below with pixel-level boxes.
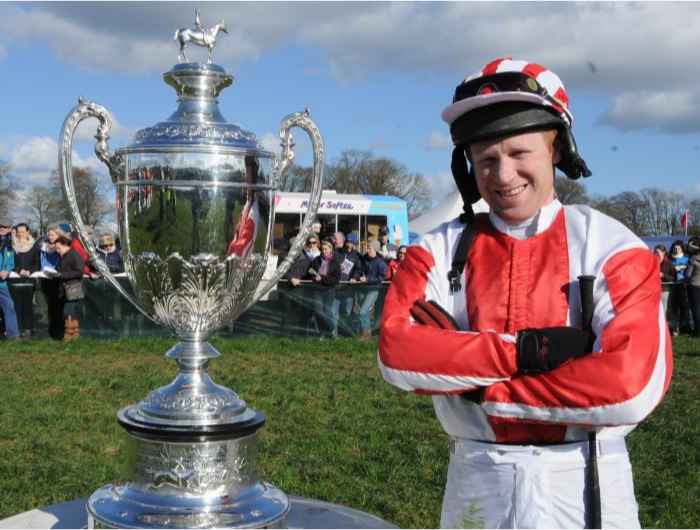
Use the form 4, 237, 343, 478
0, 338, 700, 528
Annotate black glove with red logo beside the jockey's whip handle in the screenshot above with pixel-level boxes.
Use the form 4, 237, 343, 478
516, 327, 594, 374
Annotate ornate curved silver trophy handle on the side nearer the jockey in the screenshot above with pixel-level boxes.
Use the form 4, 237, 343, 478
241, 108, 326, 312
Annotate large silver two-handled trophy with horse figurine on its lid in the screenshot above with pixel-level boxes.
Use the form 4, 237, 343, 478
59, 11, 324, 528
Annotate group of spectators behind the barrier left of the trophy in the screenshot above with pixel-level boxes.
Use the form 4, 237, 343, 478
0, 218, 124, 341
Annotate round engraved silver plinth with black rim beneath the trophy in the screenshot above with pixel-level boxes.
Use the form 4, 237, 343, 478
87, 406, 289, 528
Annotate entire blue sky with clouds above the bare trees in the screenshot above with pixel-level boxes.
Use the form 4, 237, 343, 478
0, 2, 700, 217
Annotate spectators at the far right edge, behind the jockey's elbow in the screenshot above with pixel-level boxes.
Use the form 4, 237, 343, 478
654, 237, 700, 337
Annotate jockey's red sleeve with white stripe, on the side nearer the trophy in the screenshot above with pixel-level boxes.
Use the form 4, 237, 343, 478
379, 246, 516, 394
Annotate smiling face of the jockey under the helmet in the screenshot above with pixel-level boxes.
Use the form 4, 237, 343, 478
471, 131, 559, 224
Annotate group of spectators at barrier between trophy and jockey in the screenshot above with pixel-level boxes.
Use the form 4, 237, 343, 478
279, 224, 406, 340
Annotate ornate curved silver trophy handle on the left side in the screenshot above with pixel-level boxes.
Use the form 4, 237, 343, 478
58, 98, 153, 320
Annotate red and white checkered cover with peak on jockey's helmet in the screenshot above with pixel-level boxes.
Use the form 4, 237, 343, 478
442, 57, 574, 127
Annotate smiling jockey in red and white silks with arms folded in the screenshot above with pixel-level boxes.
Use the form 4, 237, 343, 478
379, 59, 672, 528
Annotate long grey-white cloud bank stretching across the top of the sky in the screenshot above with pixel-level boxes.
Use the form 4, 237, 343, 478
0, 2, 700, 132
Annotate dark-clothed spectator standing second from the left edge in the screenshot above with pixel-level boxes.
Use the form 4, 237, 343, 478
10, 223, 41, 338
